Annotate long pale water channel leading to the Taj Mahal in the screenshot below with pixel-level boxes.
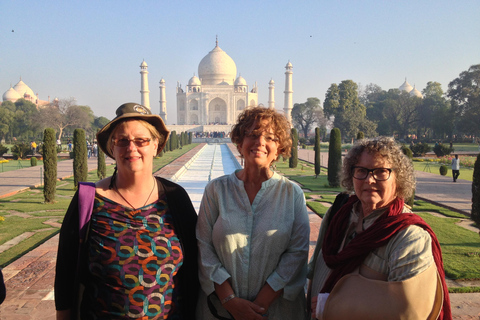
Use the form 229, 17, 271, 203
173, 144, 241, 213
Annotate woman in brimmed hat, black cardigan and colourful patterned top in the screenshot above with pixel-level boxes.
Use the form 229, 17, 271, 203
55, 103, 198, 319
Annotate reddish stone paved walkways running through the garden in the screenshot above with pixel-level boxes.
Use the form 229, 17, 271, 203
0, 145, 480, 320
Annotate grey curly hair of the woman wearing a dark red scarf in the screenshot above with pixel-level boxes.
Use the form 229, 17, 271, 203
342, 137, 415, 200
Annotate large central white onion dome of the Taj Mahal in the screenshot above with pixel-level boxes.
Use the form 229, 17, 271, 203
198, 43, 237, 85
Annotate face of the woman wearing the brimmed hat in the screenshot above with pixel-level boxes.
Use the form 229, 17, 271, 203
112, 120, 158, 173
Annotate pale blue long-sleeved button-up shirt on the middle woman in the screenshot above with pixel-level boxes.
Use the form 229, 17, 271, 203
197, 173, 310, 319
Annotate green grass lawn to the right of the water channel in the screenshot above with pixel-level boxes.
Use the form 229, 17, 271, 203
277, 162, 480, 292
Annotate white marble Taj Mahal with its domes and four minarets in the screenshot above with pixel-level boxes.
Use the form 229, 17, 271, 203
140, 40, 293, 132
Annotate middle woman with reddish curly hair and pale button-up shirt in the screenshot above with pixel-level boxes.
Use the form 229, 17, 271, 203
197, 107, 310, 320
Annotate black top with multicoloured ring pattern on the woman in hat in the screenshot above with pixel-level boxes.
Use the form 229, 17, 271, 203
81, 194, 183, 319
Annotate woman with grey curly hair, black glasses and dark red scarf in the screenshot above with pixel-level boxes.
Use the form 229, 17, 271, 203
308, 137, 452, 319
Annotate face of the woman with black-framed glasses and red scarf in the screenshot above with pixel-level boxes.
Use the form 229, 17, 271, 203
353, 151, 397, 216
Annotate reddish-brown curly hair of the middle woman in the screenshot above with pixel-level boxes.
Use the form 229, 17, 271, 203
230, 106, 292, 162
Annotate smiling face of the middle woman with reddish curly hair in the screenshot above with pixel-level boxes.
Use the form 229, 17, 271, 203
239, 120, 278, 168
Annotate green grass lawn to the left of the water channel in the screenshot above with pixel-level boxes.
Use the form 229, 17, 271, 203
0, 143, 198, 267
